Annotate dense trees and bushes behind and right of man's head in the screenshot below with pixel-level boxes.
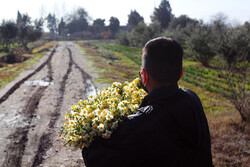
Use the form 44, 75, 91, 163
118, 0, 250, 67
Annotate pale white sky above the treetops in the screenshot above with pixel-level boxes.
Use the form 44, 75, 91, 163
0, 0, 250, 25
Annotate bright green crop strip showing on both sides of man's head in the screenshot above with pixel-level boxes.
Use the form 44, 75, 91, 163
97, 43, 249, 97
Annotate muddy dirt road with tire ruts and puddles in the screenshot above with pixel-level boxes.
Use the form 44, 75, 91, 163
0, 42, 98, 167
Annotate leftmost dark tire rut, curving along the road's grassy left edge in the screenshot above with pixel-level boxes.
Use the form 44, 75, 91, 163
0, 44, 58, 104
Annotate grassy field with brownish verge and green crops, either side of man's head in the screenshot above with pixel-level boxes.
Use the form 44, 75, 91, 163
77, 41, 240, 112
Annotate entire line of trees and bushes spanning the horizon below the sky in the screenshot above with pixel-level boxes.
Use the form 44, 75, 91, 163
0, 0, 250, 66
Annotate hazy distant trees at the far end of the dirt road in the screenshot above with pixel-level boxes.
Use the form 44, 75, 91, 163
46, 8, 120, 39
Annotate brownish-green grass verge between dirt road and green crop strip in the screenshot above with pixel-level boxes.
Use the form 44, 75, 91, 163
76, 41, 140, 84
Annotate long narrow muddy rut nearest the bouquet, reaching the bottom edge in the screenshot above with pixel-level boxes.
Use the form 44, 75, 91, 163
32, 48, 73, 167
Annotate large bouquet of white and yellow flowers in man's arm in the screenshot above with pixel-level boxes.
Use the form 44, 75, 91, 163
59, 78, 146, 149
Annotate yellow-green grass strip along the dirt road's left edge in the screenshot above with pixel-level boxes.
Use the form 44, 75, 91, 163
0, 41, 56, 89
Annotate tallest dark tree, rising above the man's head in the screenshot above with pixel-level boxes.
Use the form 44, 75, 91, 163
151, 0, 172, 29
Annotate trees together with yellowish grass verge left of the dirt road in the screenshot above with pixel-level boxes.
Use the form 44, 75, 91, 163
0, 11, 56, 88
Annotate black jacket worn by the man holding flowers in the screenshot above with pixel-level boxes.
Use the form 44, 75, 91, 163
82, 84, 213, 167
